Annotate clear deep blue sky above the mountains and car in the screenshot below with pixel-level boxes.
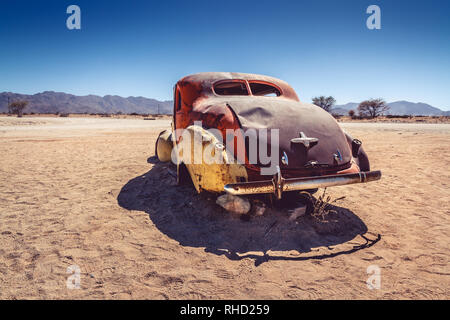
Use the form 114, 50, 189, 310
0, 0, 450, 110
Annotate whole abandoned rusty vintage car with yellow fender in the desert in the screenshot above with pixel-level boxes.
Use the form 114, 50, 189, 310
156, 72, 381, 198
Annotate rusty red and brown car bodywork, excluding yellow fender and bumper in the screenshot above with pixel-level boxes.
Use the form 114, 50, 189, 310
165, 72, 380, 194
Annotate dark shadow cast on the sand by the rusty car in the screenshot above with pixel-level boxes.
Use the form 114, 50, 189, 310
117, 158, 380, 265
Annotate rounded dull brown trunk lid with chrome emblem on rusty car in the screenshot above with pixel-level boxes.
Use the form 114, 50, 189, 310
203, 97, 352, 174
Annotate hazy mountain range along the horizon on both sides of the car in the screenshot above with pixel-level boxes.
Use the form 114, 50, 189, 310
0, 91, 450, 116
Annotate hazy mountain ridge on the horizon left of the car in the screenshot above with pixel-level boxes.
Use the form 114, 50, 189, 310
0, 91, 173, 114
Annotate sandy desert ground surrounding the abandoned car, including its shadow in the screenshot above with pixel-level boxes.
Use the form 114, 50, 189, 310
0, 117, 450, 299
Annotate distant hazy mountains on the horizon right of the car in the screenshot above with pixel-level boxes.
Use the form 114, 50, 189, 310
331, 101, 450, 116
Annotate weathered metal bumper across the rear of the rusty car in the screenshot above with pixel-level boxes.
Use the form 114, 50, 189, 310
224, 168, 381, 199
